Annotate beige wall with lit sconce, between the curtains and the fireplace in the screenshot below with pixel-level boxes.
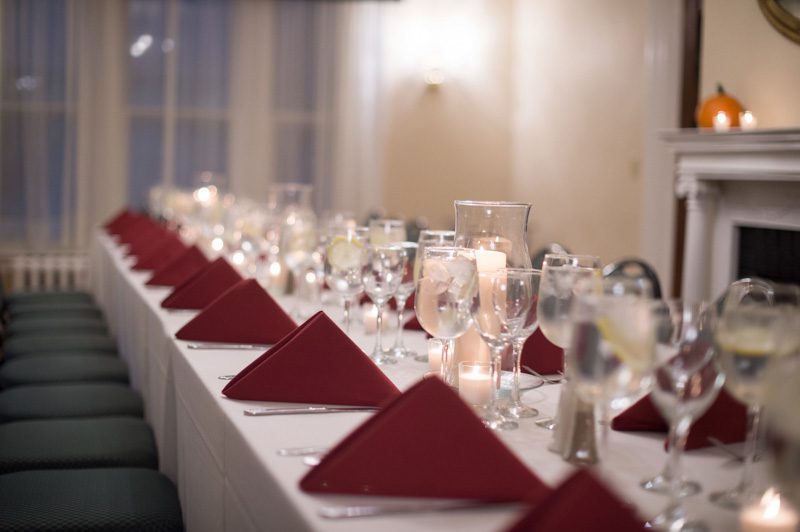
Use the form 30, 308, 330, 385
384, 0, 647, 262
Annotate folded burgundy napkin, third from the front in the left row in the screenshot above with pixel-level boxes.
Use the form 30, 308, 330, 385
222, 311, 400, 406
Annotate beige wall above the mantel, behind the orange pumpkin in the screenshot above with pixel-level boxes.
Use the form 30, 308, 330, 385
700, 0, 800, 127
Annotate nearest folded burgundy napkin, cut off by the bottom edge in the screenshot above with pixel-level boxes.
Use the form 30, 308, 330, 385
506, 469, 645, 532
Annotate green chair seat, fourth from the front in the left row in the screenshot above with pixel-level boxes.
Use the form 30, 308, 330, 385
0, 354, 128, 388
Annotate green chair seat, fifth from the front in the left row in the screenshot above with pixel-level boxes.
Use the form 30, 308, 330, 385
2, 334, 117, 360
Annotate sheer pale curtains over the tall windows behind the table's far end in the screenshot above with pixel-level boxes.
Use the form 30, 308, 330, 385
0, 0, 382, 252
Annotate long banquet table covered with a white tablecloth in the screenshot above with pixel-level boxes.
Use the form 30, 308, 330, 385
91, 232, 767, 532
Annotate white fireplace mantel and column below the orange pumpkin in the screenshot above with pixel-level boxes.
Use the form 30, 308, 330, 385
663, 129, 800, 299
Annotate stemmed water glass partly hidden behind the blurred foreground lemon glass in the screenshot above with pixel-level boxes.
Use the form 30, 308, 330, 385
536, 253, 601, 430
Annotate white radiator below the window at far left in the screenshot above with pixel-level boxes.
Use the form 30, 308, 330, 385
3, 254, 89, 292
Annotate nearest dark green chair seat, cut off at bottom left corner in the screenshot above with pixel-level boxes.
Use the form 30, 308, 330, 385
0, 468, 183, 532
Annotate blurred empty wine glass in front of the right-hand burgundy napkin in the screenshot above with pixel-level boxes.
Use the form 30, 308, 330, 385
641, 300, 724, 531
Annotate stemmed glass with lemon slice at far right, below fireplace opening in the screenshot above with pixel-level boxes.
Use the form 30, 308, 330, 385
709, 285, 800, 509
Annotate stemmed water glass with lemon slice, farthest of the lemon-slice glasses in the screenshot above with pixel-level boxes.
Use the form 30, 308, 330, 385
325, 227, 367, 334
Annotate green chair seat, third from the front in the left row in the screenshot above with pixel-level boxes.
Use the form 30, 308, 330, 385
0, 382, 144, 423
